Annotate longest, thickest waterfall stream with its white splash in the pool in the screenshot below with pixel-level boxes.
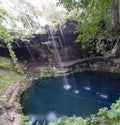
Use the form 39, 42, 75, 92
48, 26, 71, 90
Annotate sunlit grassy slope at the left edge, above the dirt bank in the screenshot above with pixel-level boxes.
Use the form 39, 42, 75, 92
0, 57, 22, 93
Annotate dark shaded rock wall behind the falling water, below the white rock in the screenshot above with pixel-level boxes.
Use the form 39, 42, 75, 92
0, 19, 80, 63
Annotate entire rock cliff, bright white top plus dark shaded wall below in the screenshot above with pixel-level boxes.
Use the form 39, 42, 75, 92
0, 0, 85, 74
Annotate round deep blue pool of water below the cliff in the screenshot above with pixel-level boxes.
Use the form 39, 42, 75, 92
21, 71, 120, 125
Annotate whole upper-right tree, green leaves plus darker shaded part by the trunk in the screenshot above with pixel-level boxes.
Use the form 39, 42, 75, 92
59, 0, 119, 47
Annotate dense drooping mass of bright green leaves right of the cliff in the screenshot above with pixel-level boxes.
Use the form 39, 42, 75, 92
77, 0, 111, 45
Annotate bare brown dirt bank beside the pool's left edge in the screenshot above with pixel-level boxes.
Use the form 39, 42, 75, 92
0, 82, 25, 125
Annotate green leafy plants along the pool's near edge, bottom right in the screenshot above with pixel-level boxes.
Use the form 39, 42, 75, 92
49, 100, 120, 125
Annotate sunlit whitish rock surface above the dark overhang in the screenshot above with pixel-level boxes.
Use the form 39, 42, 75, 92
0, 0, 66, 36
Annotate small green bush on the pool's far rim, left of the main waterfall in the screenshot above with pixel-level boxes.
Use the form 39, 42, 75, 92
40, 67, 56, 78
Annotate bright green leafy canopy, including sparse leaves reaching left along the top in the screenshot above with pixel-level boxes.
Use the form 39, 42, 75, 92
59, 0, 112, 45
